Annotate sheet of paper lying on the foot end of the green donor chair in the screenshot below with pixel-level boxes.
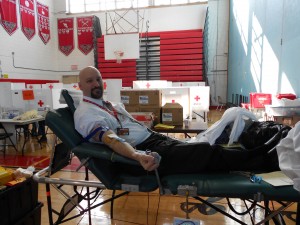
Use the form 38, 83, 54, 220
257, 171, 293, 186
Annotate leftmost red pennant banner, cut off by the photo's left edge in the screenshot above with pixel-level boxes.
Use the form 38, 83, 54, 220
0, 0, 18, 35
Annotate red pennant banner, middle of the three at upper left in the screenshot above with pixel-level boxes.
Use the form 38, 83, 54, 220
20, 0, 35, 40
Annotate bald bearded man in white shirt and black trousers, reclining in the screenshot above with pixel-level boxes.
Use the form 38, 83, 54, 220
74, 67, 279, 175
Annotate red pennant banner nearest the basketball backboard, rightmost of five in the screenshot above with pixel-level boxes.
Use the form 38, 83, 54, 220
77, 16, 94, 55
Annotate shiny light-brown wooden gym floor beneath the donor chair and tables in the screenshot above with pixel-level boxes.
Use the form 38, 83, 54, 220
0, 111, 296, 225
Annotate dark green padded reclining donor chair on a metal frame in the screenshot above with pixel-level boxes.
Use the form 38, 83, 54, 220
34, 90, 300, 225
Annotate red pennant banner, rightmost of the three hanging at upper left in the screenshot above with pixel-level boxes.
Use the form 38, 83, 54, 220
36, 2, 50, 44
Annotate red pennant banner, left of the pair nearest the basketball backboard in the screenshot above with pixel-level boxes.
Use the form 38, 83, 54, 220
57, 18, 74, 56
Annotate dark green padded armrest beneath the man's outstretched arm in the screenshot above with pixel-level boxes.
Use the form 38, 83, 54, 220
72, 142, 140, 166
